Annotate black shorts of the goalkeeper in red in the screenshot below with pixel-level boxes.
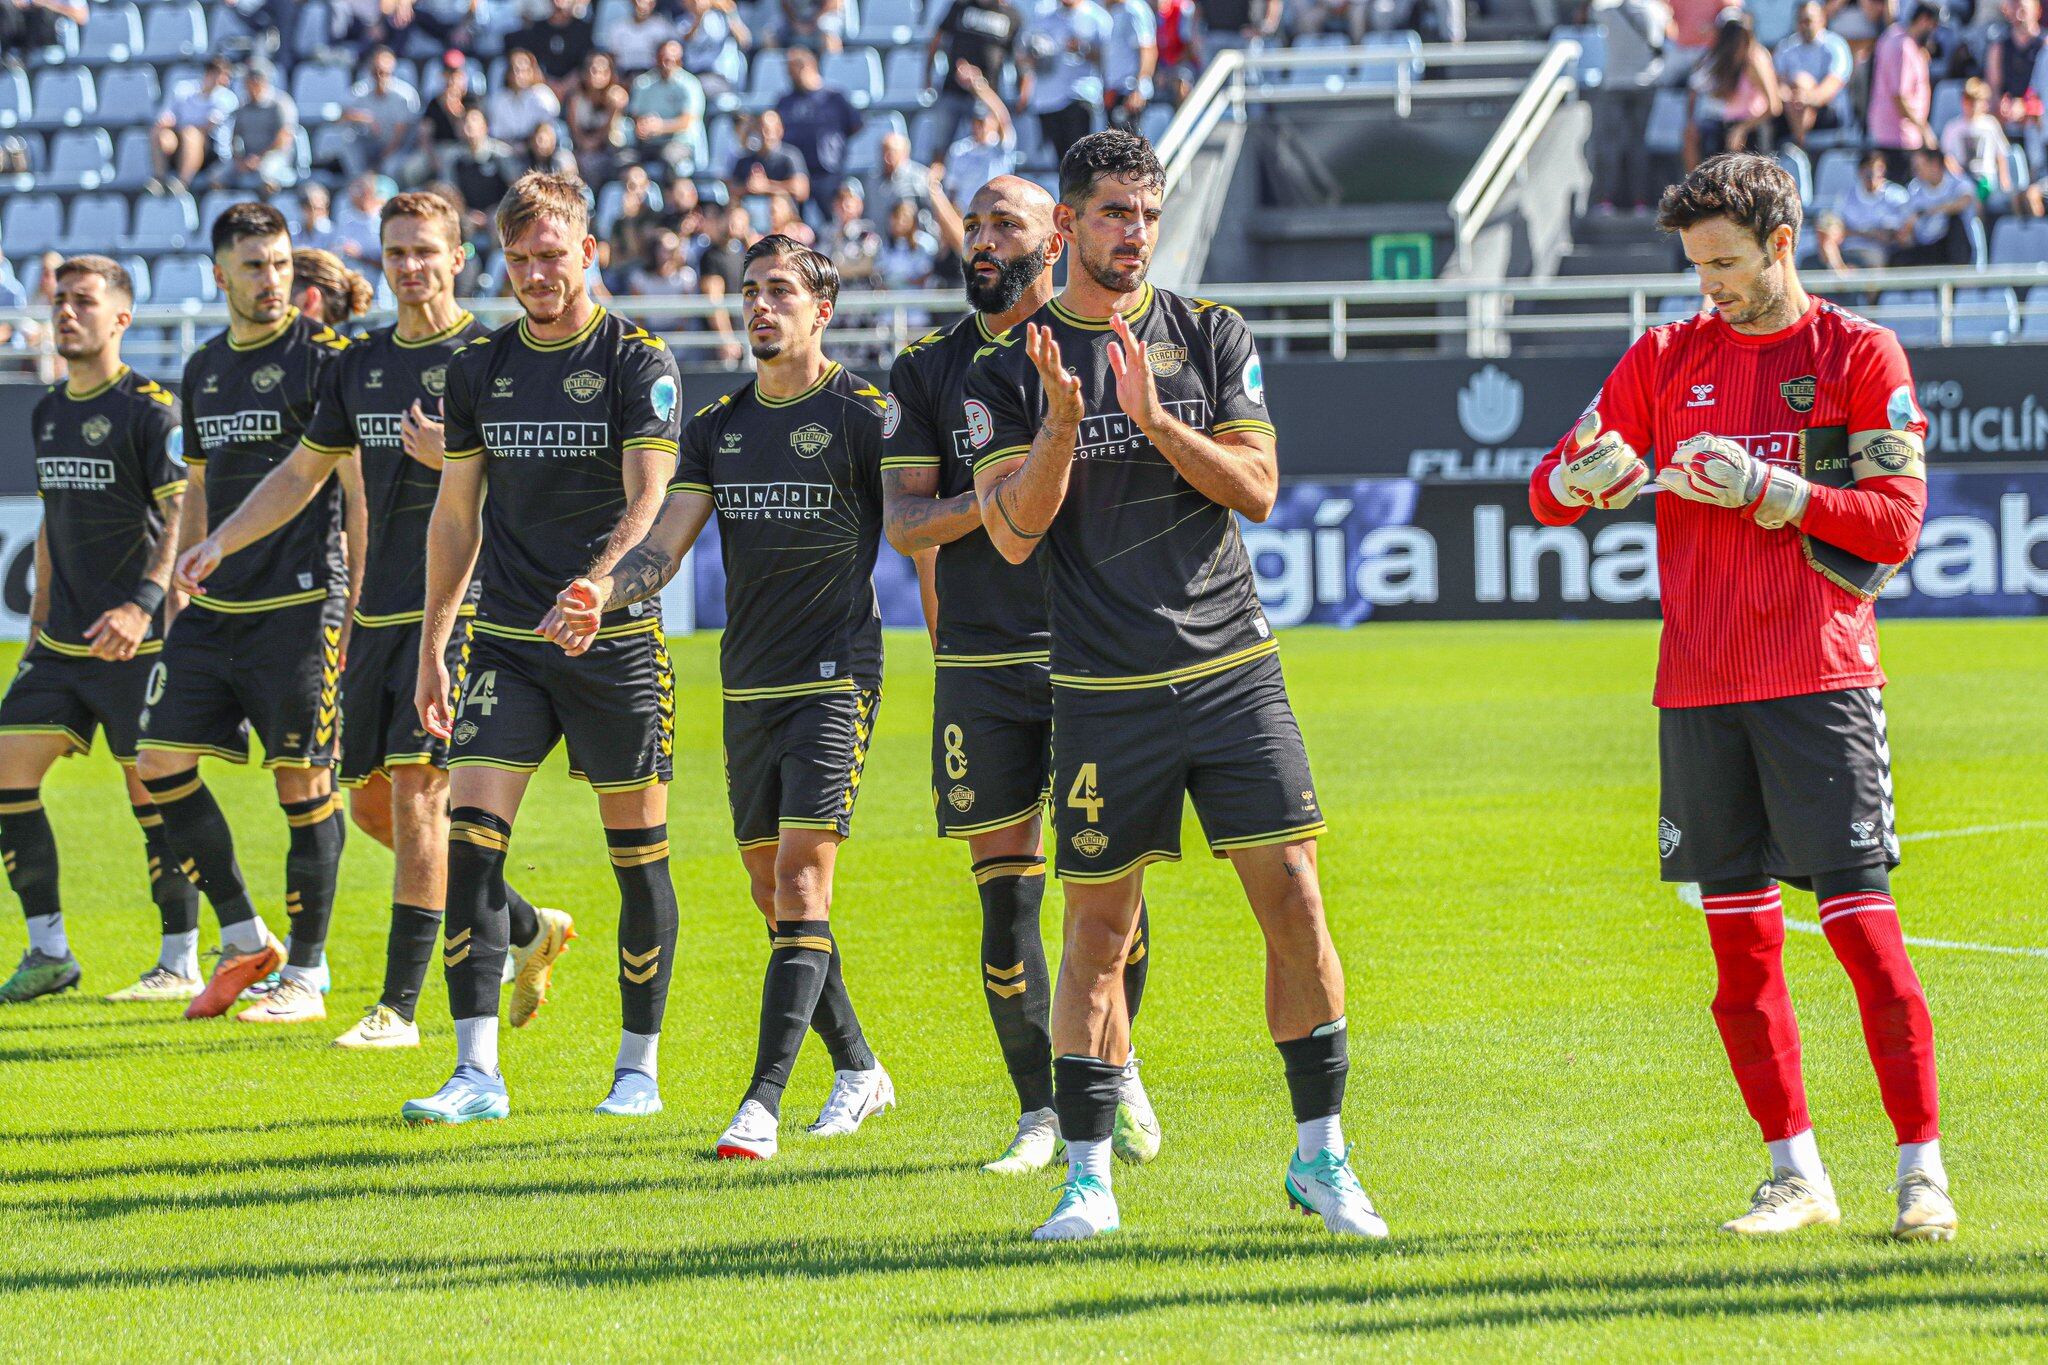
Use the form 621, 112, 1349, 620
1657, 688, 1898, 882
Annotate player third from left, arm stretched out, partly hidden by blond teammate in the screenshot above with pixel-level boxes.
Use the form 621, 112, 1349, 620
178, 192, 573, 1048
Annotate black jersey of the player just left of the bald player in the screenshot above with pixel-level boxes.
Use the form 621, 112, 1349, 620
670, 362, 883, 702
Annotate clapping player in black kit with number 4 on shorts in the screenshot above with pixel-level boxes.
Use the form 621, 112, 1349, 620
963, 129, 1386, 1240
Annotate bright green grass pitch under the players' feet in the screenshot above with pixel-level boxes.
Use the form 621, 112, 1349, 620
0, 622, 2048, 1361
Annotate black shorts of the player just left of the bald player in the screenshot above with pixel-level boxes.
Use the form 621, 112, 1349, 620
725, 684, 883, 849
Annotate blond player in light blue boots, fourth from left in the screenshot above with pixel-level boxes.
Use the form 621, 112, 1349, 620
403, 172, 682, 1124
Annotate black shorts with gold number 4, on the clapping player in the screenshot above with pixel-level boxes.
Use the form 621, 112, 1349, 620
1053, 655, 1325, 882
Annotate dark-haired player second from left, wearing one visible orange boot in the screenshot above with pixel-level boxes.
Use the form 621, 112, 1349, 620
135, 203, 348, 1023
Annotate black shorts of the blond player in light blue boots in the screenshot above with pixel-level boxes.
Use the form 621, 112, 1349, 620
449, 618, 676, 792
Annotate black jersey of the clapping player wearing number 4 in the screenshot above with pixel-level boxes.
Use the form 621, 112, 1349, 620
963, 284, 1278, 688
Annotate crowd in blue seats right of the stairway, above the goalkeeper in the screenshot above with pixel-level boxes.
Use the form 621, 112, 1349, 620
1583, 0, 2048, 270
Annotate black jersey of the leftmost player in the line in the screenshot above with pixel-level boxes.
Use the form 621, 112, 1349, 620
31, 366, 184, 655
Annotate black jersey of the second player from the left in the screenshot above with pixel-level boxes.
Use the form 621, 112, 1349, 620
180, 309, 348, 612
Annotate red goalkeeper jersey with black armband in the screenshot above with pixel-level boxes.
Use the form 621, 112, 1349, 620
1530, 299, 1927, 706
